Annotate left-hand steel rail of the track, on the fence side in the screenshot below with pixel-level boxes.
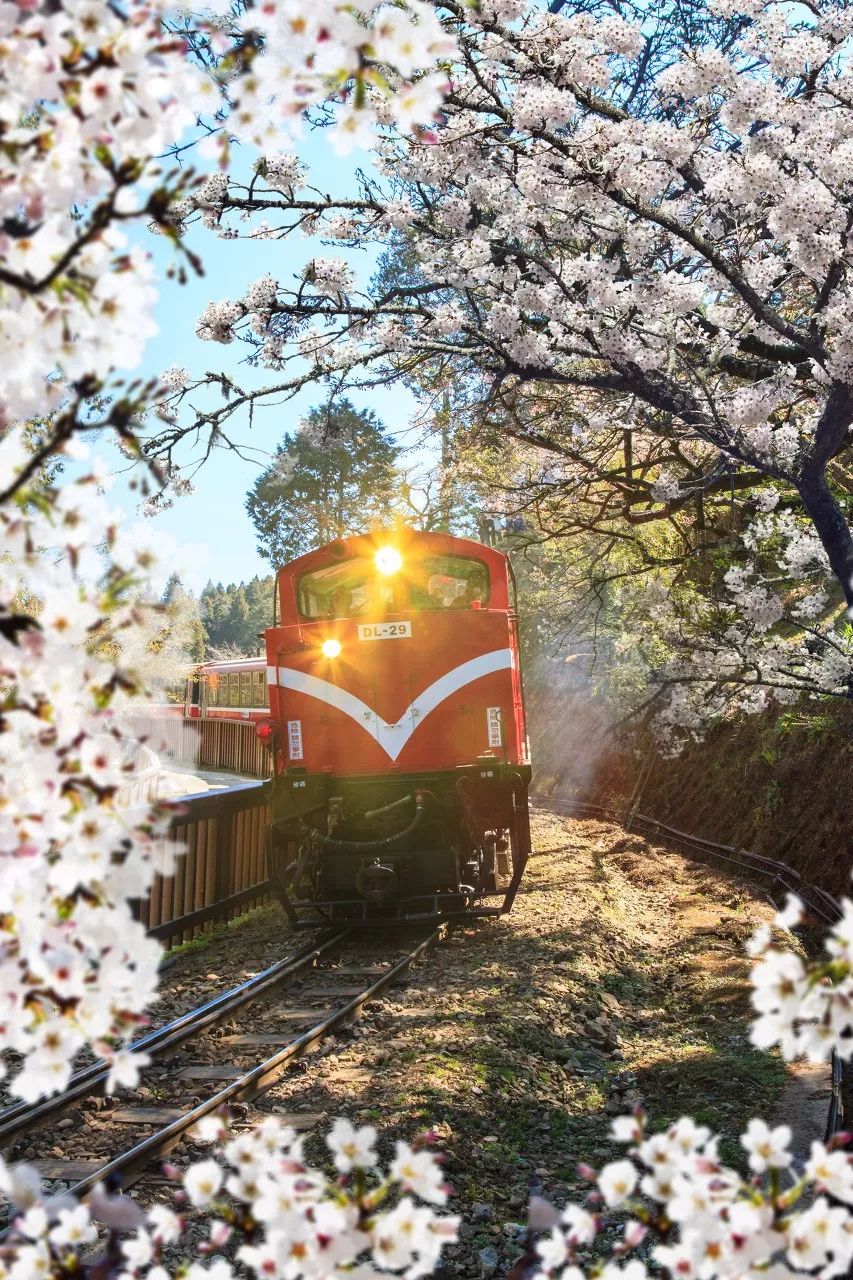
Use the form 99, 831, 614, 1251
0, 928, 350, 1143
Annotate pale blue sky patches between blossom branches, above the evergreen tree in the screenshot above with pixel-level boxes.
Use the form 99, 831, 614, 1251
99, 133, 415, 593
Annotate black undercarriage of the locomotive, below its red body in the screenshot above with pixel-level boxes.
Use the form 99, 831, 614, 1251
268, 758, 530, 928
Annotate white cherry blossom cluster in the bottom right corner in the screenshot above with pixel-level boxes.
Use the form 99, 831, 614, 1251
537, 1112, 853, 1280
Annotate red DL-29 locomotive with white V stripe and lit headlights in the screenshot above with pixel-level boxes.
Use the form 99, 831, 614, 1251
256, 531, 530, 925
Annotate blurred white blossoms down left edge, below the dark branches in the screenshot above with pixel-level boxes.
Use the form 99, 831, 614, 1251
0, 431, 179, 1101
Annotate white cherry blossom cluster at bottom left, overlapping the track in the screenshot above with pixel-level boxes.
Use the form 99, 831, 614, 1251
0, 1116, 459, 1280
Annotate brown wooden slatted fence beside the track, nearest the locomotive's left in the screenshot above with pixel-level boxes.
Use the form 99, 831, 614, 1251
137, 782, 270, 945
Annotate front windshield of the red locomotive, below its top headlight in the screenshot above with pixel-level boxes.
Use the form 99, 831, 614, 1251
297, 556, 489, 618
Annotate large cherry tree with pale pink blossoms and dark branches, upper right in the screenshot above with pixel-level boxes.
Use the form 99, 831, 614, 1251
169, 0, 853, 745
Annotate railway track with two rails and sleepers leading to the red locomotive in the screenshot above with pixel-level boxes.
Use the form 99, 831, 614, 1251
0, 925, 444, 1213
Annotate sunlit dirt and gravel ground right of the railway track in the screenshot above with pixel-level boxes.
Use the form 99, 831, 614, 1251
153, 810, 822, 1276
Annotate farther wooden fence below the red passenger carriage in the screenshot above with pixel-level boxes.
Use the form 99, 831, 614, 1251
131, 716, 270, 778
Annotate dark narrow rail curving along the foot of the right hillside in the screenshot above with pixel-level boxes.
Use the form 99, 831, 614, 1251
530, 795, 845, 1142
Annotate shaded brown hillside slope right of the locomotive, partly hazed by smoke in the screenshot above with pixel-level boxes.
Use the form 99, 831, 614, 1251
526, 662, 853, 893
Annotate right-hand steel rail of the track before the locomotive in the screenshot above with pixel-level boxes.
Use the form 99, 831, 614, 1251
57, 924, 444, 1201
